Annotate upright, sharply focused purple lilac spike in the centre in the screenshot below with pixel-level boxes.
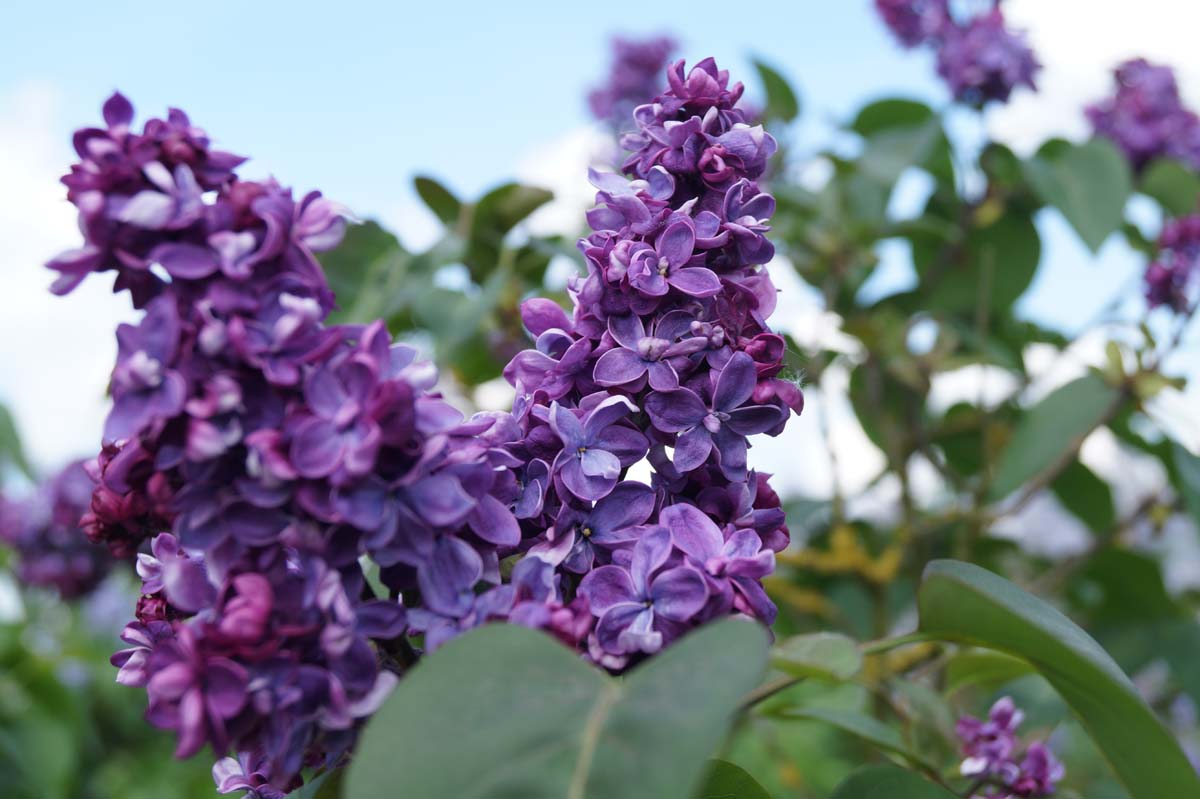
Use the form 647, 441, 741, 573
504, 59, 803, 669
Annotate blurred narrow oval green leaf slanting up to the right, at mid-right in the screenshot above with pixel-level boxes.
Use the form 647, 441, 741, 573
990, 372, 1121, 500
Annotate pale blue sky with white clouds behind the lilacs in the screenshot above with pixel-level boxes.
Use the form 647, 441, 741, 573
0, 0, 1200, 468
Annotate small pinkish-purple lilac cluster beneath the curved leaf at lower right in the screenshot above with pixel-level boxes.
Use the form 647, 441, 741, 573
958, 697, 1064, 799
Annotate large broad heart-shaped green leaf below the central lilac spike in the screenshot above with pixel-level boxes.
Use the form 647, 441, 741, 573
344, 619, 767, 799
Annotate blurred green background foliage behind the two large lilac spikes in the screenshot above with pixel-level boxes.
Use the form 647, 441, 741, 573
0, 15, 1200, 799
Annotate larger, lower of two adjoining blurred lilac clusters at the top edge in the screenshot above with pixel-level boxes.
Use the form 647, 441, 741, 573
937, 7, 1040, 106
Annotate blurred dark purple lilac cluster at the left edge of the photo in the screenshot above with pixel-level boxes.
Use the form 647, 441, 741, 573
0, 463, 115, 600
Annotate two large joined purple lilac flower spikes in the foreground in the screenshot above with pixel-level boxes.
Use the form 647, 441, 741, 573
49, 59, 803, 797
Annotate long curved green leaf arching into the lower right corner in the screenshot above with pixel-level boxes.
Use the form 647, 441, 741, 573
917, 560, 1200, 799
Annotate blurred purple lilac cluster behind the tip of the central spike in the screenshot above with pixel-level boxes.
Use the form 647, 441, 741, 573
588, 36, 679, 128
